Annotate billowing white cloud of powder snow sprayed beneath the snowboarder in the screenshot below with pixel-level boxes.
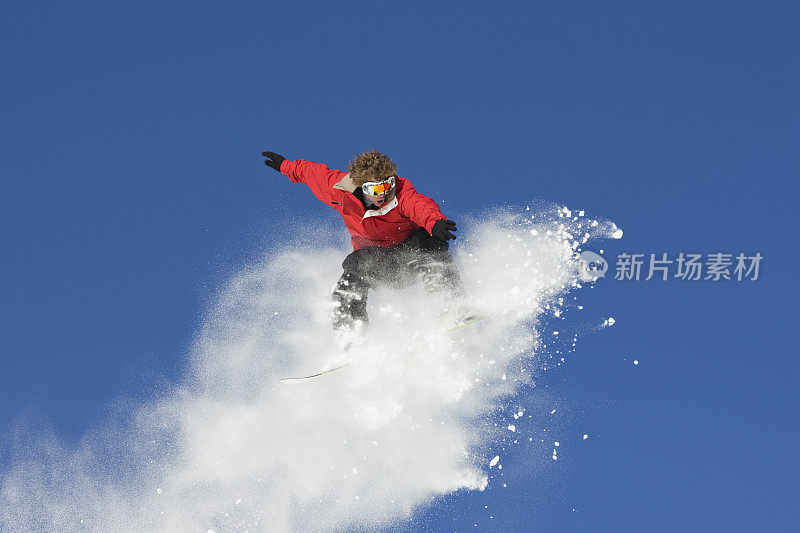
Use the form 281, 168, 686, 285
0, 206, 615, 532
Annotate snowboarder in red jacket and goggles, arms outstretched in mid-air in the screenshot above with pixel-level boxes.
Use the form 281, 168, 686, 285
261, 150, 463, 330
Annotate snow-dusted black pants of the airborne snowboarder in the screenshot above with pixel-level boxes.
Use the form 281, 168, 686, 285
333, 228, 464, 329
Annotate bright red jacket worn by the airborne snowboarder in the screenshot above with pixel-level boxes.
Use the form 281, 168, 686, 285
281, 159, 445, 250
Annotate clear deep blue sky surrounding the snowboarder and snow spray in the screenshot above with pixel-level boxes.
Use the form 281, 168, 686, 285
0, 2, 800, 532
